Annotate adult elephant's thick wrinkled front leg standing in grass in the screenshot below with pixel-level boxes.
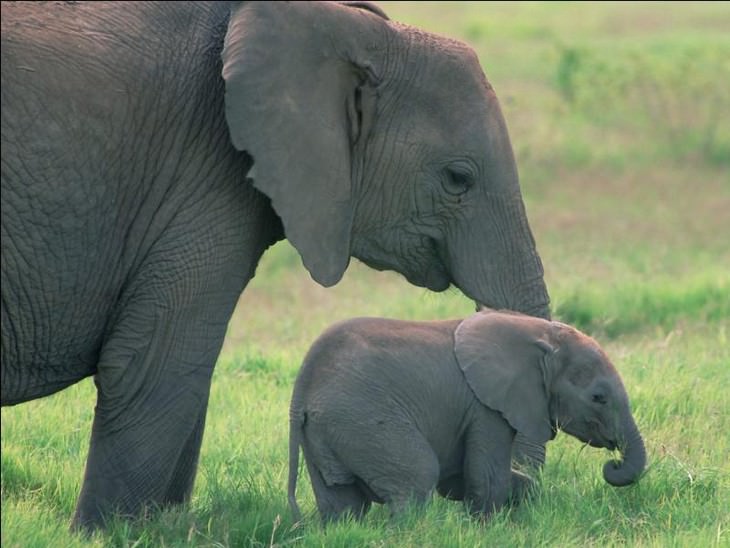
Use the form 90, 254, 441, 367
69, 215, 260, 529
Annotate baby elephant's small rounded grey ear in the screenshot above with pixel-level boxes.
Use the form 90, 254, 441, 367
454, 312, 554, 443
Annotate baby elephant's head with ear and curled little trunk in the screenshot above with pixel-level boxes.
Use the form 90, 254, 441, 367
455, 312, 646, 486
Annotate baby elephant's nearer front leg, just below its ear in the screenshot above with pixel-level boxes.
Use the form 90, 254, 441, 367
464, 406, 514, 517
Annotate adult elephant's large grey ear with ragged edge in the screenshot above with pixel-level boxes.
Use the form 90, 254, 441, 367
222, 2, 387, 286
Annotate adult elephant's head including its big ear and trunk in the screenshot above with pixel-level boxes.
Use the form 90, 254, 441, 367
223, 2, 549, 317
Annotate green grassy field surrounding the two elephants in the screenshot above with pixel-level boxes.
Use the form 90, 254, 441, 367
1, 2, 730, 547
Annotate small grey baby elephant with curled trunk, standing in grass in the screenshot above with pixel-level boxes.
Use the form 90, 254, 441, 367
289, 311, 646, 521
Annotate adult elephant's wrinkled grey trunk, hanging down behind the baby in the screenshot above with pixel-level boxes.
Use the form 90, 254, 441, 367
442, 89, 550, 319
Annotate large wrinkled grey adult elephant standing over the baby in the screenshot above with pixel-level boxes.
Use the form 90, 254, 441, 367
2, 2, 548, 528
